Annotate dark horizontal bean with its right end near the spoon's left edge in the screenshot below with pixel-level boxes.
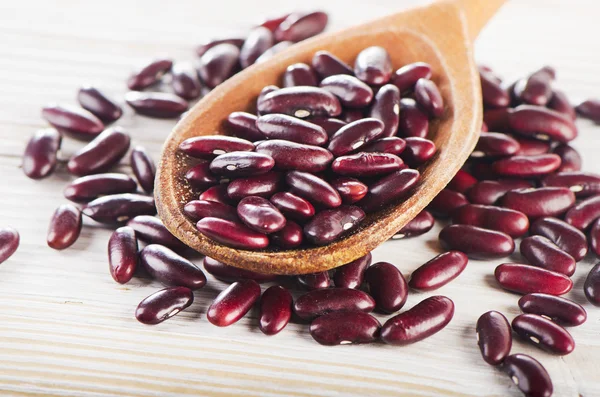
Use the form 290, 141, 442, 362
81, 193, 156, 223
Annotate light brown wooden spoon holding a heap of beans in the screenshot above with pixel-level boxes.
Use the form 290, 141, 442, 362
156, 0, 505, 274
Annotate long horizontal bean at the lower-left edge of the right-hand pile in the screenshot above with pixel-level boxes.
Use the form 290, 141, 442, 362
439, 225, 515, 259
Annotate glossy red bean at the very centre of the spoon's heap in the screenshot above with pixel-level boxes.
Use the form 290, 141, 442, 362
256, 139, 333, 172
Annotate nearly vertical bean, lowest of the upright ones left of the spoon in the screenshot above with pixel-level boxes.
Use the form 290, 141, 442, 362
108, 226, 139, 284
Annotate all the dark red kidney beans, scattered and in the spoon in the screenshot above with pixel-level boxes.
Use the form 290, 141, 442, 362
0, 8, 600, 396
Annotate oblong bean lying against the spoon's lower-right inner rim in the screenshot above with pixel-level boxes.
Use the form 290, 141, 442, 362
360, 169, 420, 212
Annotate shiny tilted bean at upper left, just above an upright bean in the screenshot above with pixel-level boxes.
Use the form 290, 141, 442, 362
42, 104, 104, 140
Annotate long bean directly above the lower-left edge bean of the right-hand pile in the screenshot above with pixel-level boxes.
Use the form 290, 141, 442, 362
452, 204, 529, 238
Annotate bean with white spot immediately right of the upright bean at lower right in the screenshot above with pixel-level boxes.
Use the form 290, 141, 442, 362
512, 314, 575, 356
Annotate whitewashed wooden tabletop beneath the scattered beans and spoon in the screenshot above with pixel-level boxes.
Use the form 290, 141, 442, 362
0, 0, 600, 397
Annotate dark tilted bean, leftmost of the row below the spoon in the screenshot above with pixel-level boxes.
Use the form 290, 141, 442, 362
135, 287, 194, 325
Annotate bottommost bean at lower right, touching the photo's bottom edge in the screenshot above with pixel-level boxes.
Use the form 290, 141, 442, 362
501, 354, 553, 397
